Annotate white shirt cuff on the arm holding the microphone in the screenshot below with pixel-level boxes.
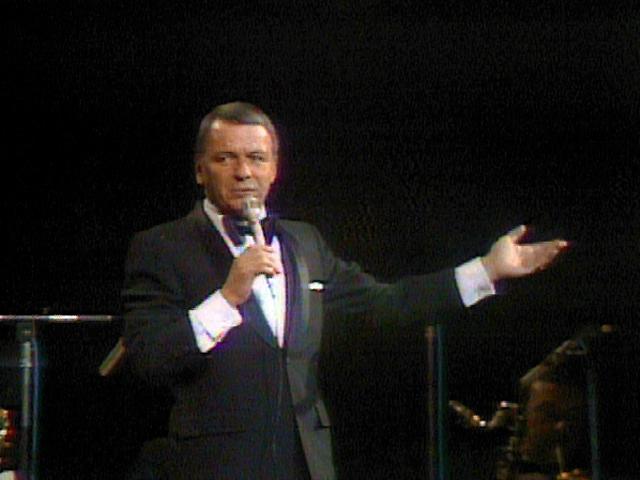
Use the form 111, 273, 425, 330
189, 290, 242, 353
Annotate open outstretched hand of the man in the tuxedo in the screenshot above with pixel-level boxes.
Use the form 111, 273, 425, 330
482, 225, 569, 283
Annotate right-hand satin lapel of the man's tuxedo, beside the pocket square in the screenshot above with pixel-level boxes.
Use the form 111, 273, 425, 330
276, 222, 309, 351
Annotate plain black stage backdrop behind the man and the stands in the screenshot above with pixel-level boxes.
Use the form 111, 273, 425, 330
0, 0, 640, 478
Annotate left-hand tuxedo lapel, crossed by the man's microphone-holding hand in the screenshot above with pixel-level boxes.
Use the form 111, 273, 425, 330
189, 202, 277, 348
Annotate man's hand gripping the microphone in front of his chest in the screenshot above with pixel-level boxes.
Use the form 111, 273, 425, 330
222, 245, 282, 307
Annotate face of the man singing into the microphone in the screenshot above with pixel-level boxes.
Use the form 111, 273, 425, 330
196, 120, 277, 215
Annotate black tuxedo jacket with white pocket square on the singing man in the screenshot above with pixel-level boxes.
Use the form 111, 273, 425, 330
123, 203, 462, 479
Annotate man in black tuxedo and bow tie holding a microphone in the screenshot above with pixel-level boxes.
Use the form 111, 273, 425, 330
123, 102, 567, 480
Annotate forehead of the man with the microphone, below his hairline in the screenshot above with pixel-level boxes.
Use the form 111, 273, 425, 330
207, 120, 273, 151
